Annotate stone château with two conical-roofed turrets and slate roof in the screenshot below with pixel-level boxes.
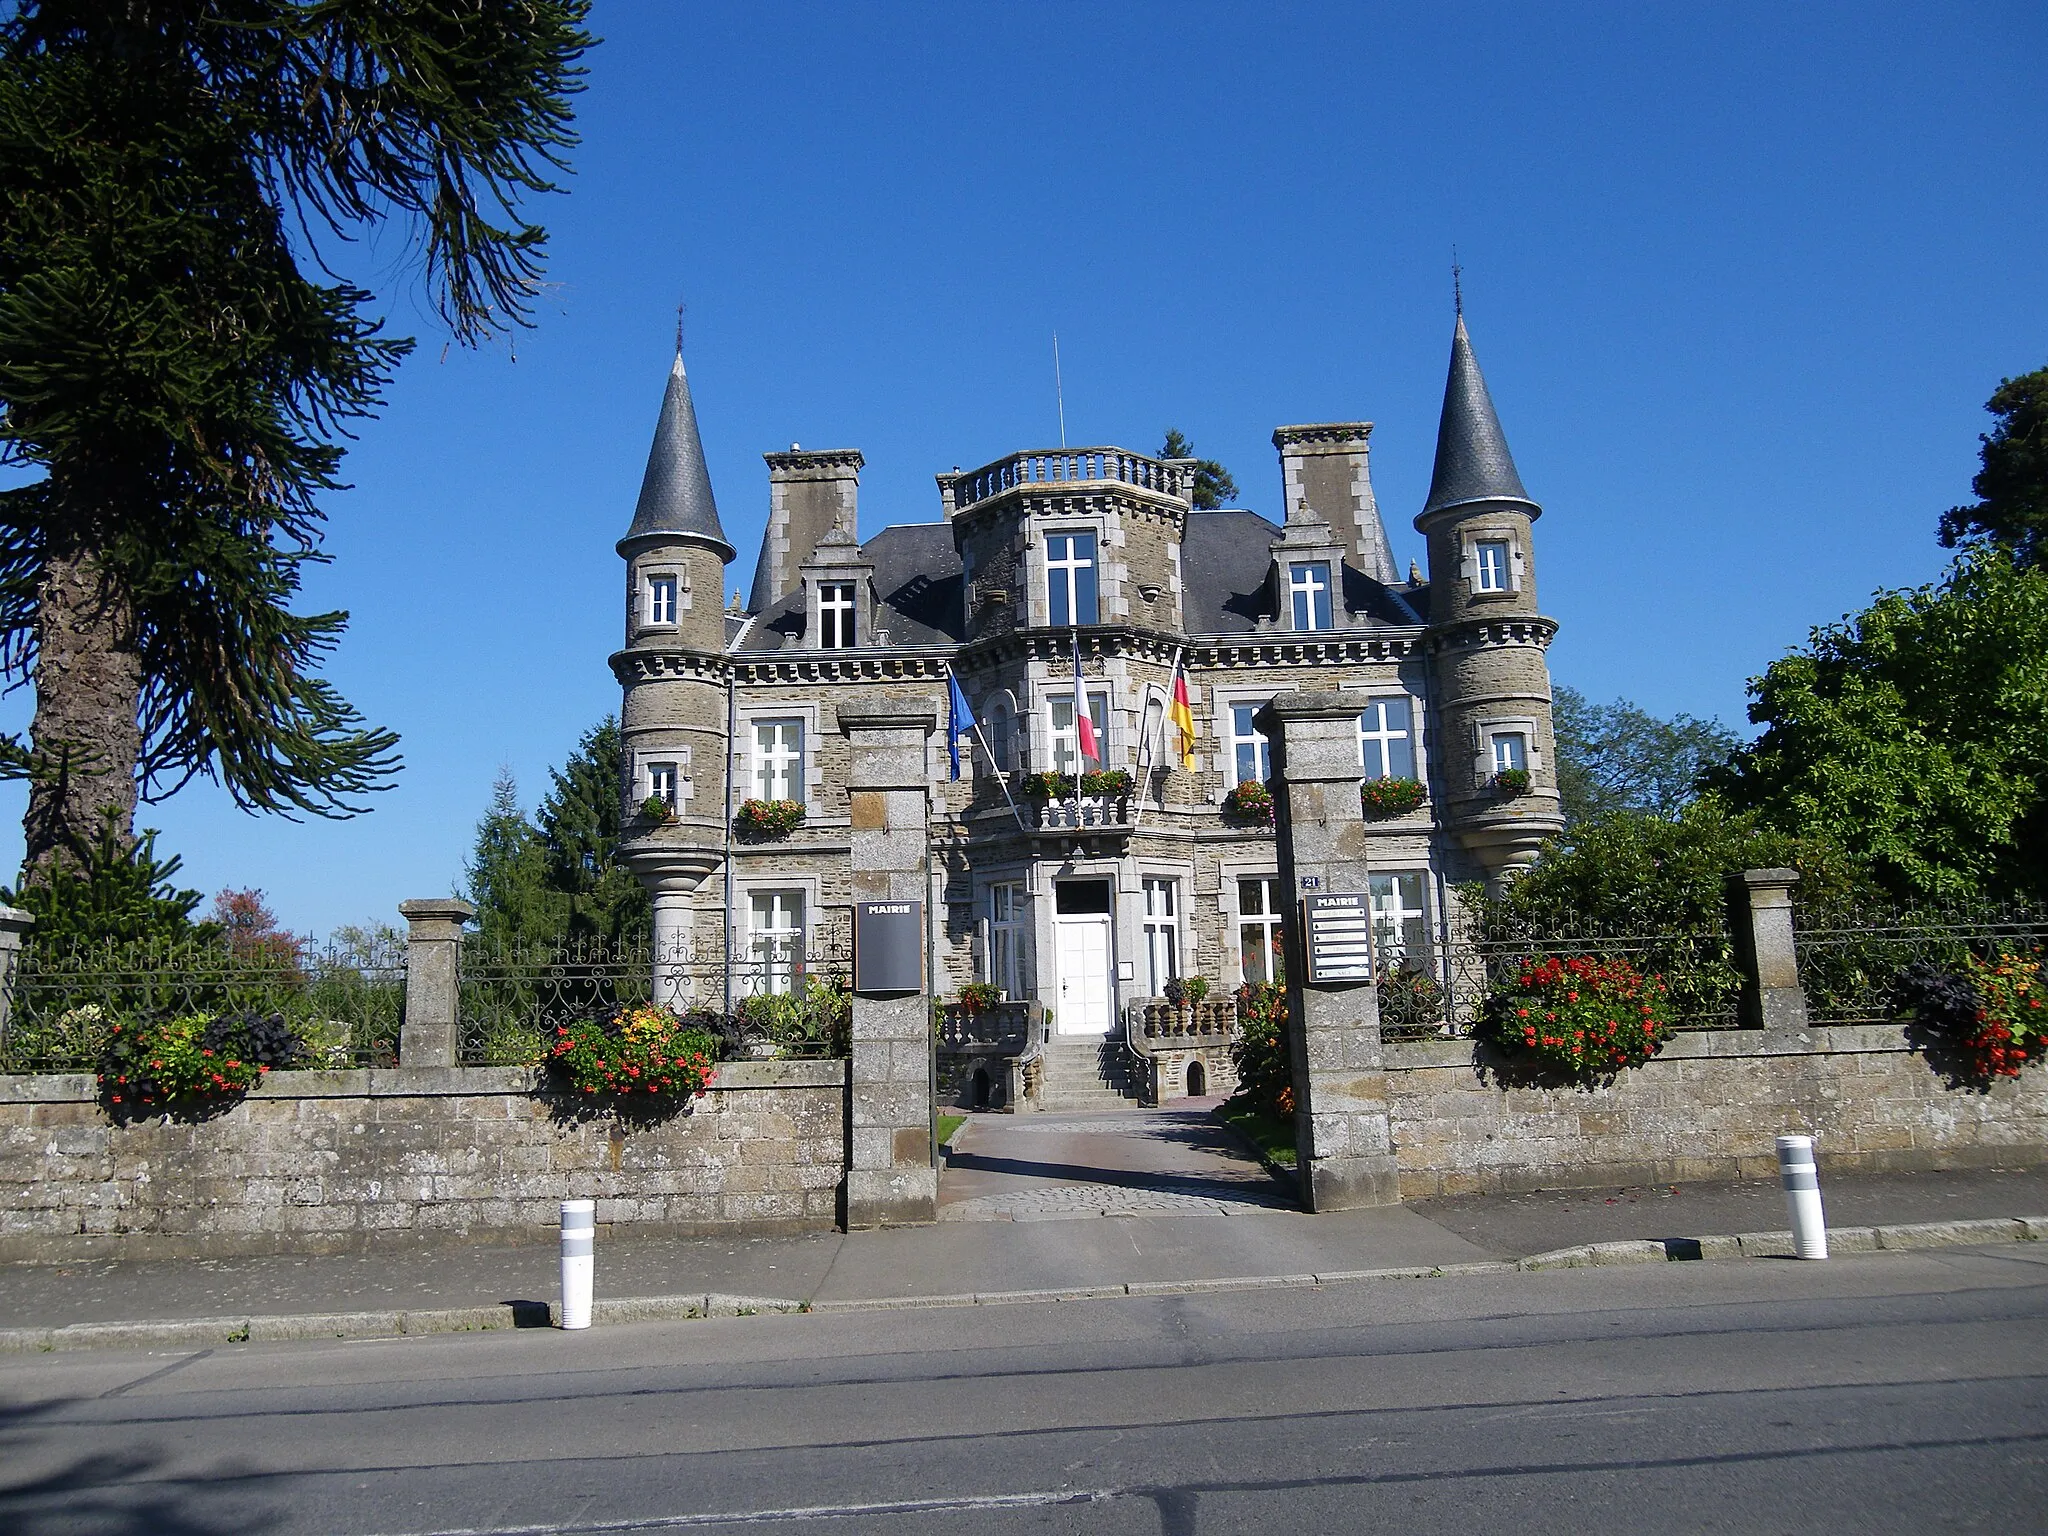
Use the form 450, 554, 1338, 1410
612, 315, 1561, 1083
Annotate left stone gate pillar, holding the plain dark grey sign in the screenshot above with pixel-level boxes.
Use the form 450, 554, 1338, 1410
840, 702, 938, 1229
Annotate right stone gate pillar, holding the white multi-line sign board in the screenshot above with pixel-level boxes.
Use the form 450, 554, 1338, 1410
1257, 692, 1401, 1210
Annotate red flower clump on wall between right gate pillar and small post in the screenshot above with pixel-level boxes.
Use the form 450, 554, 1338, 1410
1489, 954, 1671, 1079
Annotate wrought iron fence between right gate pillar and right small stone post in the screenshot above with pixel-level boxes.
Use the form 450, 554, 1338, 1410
1378, 924, 1743, 1040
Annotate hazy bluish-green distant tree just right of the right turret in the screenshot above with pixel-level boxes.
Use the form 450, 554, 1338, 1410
1550, 688, 1741, 821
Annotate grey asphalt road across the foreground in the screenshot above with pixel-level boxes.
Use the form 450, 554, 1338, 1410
0, 1243, 2048, 1536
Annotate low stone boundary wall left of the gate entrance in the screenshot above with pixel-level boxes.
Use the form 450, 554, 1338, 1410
0, 1061, 846, 1260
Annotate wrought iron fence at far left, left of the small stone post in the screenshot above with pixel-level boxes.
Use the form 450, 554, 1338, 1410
0, 936, 406, 1071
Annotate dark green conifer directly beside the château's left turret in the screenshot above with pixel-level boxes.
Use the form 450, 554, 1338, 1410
537, 715, 653, 940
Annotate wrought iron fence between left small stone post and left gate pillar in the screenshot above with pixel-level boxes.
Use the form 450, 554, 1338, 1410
457, 938, 852, 1067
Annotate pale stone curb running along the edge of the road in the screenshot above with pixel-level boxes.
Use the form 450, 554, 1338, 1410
0, 1217, 2048, 1354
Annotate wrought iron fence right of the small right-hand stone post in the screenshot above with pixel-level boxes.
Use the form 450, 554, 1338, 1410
1792, 903, 2048, 1024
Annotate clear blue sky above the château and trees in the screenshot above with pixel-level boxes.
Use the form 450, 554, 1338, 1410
0, 0, 2048, 932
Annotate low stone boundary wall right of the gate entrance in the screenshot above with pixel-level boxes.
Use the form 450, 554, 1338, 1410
1386, 1024, 2048, 1200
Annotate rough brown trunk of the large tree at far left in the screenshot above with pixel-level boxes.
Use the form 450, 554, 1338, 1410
23, 549, 141, 881
